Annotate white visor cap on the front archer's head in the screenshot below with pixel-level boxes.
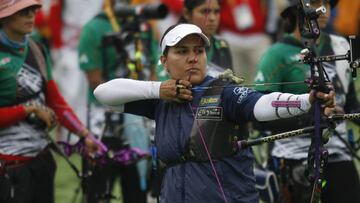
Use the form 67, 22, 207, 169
160, 23, 210, 53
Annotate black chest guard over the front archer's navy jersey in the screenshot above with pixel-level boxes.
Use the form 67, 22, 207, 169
189, 79, 249, 161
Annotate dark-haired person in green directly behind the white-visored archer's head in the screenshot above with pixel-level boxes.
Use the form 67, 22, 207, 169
156, 0, 233, 81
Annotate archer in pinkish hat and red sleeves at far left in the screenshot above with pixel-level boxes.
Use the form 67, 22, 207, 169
0, 0, 102, 203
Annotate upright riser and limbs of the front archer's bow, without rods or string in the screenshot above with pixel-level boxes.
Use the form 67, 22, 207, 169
298, 0, 330, 203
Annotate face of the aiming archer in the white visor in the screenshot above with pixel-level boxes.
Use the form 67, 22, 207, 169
160, 34, 207, 85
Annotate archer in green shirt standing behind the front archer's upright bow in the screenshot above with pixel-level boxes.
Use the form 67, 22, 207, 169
255, 0, 360, 203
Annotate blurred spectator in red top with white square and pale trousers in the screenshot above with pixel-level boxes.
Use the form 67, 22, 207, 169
220, 0, 278, 81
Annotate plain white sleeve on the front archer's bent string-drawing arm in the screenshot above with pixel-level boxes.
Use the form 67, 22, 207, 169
94, 78, 161, 106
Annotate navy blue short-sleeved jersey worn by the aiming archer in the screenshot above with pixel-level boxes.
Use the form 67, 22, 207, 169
125, 77, 262, 203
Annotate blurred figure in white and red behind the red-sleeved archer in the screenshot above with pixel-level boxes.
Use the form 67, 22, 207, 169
35, 0, 102, 142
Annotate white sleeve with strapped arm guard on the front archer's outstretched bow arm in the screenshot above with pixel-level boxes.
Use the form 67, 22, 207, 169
254, 92, 311, 121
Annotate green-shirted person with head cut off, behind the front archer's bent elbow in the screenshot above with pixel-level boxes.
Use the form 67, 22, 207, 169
79, 0, 157, 203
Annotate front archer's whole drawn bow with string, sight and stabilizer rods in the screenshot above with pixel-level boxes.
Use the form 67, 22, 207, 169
194, 0, 359, 202
